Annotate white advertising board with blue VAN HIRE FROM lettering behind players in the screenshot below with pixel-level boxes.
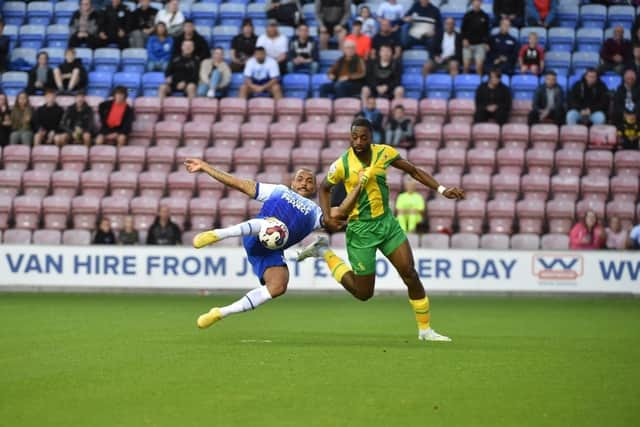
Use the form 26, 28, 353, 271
0, 245, 640, 295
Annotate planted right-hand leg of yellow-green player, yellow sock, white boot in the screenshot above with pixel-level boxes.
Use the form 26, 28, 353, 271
387, 240, 451, 341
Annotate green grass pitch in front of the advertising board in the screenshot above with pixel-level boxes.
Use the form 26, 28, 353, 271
0, 294, 640, 427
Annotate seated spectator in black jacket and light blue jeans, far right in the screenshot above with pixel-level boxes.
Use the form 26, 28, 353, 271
567, 68, 609, 126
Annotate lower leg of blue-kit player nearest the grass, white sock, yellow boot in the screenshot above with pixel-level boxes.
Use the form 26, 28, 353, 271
197, 266, 289, 329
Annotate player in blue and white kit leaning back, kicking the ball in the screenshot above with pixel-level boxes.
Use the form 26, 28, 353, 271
184, 159, 367, 328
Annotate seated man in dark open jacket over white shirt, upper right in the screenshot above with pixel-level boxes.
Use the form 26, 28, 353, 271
422, 18, 462, 77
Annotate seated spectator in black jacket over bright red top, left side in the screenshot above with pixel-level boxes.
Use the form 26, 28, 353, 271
96, 86, 133, 147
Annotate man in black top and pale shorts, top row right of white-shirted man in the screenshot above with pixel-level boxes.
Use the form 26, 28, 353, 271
460, 0, 491, 75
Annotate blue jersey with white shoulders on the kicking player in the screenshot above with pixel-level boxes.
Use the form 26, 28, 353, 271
256, 183, 322, 249
